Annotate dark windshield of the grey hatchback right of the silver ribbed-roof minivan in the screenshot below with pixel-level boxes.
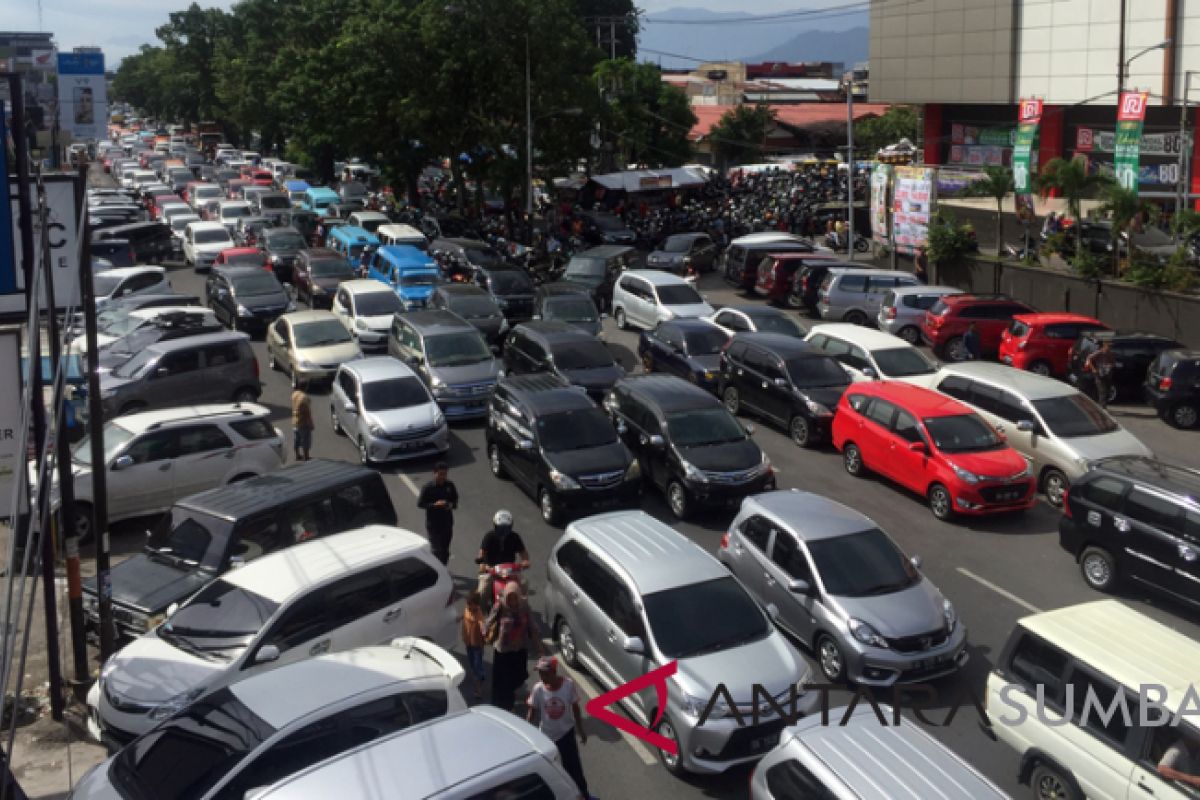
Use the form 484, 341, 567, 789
808, 528, 920, 597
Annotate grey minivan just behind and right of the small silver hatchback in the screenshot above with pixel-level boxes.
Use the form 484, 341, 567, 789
388, 311, 500, 420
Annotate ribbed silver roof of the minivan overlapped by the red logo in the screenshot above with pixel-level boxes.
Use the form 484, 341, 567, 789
564, 511, 730, 595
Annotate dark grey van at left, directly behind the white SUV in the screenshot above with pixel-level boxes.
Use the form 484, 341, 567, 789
100, 331, 263, 417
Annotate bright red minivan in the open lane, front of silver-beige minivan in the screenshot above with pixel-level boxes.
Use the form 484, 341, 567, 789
833, 380, 1037, 519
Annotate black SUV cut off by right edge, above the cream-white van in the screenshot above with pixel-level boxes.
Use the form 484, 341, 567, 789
1058, 456, 1200, 607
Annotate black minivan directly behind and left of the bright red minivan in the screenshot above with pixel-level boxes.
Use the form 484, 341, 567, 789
719, 333, 851, 447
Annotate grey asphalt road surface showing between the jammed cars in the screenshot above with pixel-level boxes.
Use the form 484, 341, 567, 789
114, 253, 1200, 798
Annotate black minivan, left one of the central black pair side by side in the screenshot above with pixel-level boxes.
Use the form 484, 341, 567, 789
486, 374, 642, 525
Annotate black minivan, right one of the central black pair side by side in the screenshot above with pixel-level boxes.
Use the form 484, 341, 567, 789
604, 374, 775, 519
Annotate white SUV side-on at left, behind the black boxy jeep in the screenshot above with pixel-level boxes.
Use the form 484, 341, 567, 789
54, 403, 283, 539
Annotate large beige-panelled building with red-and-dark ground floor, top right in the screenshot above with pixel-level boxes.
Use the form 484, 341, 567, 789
870, 0, 1200, 198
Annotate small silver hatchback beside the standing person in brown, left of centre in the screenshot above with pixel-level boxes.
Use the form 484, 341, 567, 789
329, 356, 450, 464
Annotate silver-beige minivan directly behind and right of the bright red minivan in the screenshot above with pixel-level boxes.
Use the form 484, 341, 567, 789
932, 361, 1154, 507
